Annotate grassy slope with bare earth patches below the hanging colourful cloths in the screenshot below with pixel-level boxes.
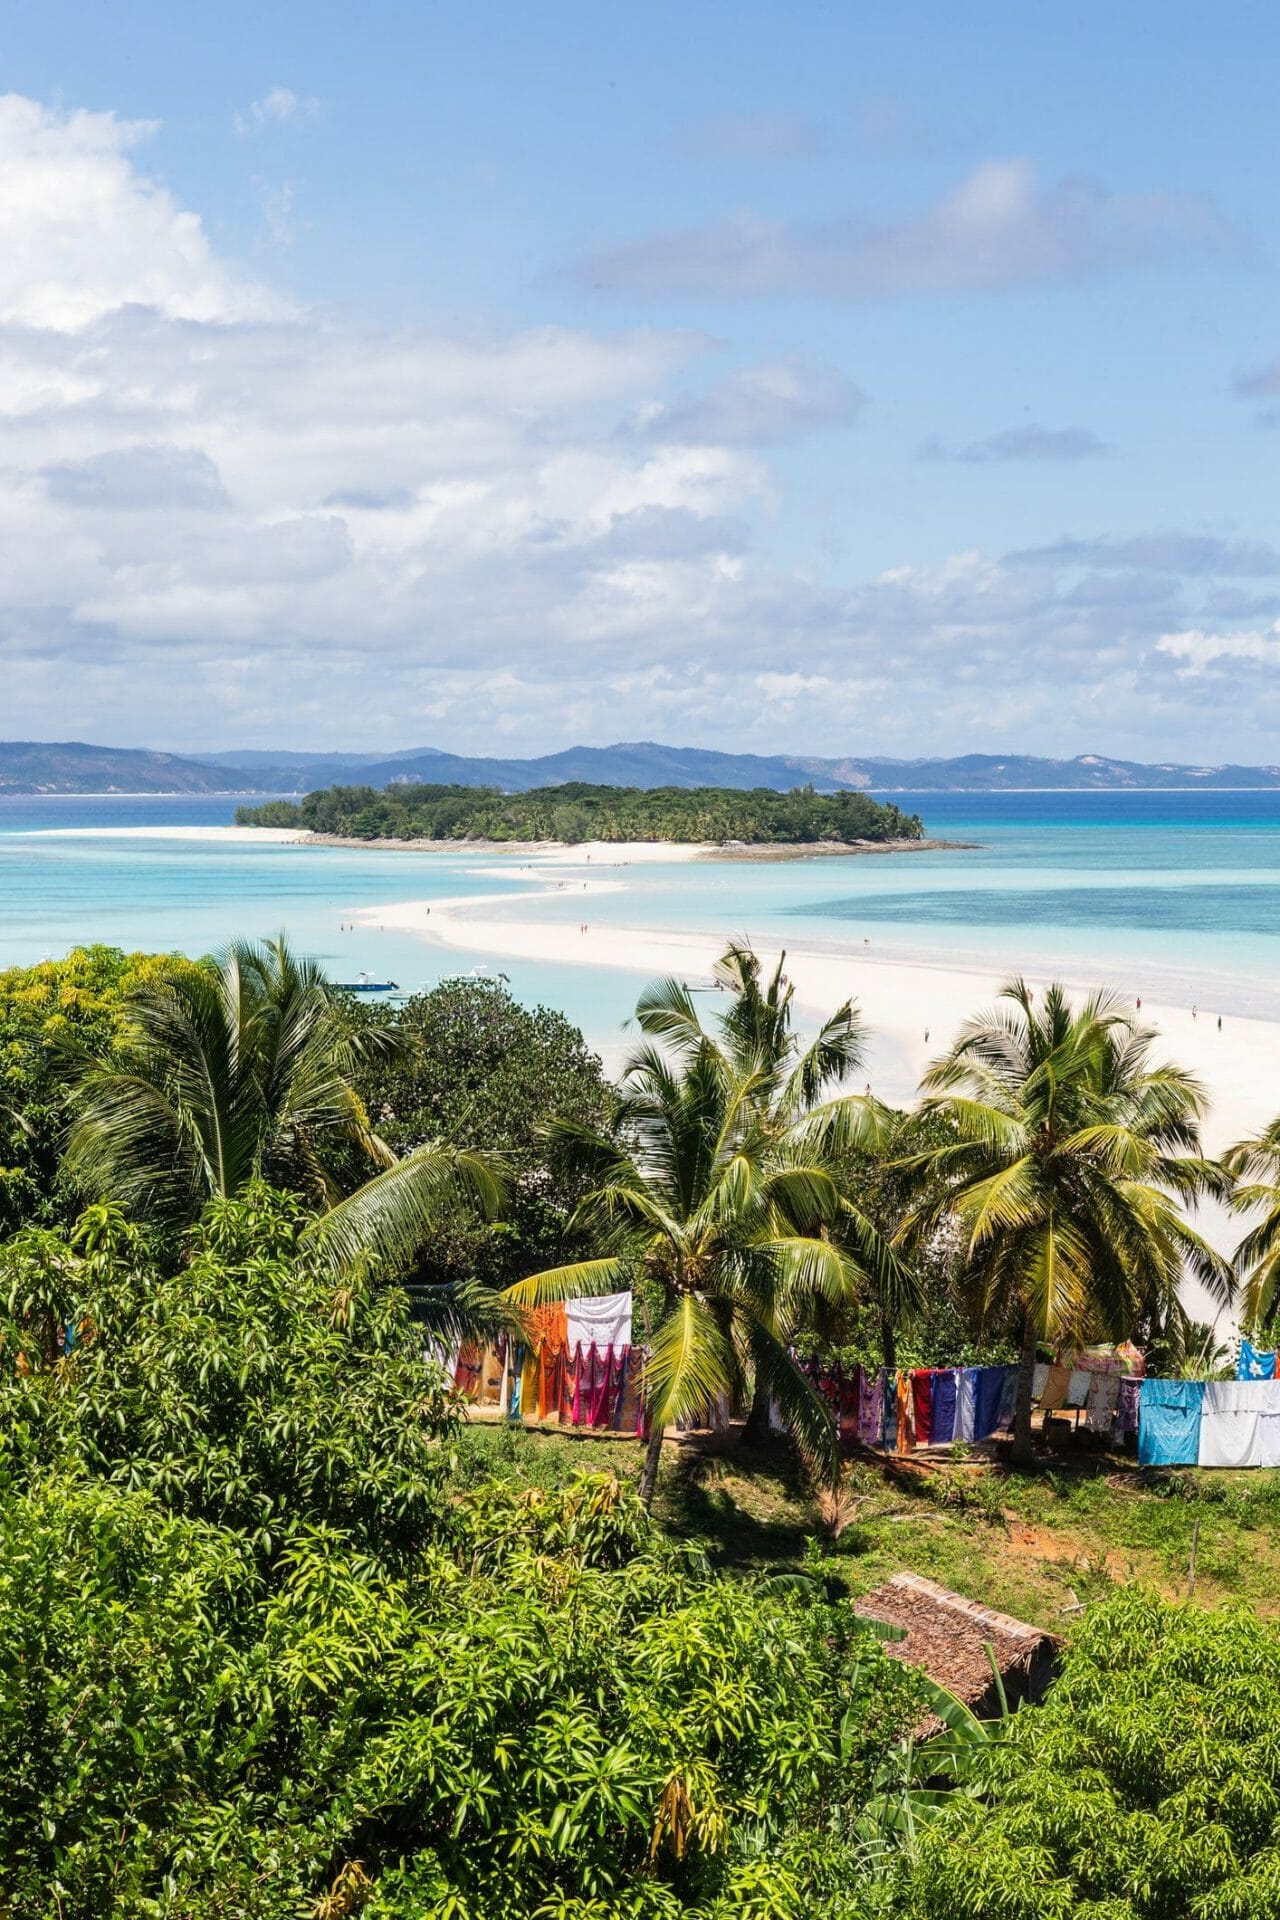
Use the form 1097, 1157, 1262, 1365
462, 1428, 1280, 1632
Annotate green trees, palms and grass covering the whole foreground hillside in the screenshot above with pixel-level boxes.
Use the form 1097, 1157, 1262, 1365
12, 941, 1280, 1920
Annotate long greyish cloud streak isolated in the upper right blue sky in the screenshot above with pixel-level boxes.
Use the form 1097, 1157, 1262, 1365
578, 159, 1242, 300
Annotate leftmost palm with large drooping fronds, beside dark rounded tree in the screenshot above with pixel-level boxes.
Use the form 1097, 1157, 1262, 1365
65, 935, 501, 1273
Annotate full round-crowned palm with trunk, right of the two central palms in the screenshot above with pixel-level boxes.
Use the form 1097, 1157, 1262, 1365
906, 979, 1234, 1461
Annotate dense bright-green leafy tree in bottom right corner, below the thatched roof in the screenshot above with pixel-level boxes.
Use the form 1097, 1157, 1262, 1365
894, 1590, 1280, 1920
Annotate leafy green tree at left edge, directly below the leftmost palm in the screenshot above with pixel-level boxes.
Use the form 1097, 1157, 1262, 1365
0, 1185, 453, 1557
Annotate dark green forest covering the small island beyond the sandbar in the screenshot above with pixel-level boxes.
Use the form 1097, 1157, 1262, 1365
236, 781, 923, 845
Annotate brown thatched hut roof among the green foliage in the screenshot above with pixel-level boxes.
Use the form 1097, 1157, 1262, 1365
856, 1572, 1061, 1718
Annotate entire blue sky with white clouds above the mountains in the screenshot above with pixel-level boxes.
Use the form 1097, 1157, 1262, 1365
0, 0, 1280, 760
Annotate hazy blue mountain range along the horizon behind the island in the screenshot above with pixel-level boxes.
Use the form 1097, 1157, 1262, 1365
0, 741, 1280, 793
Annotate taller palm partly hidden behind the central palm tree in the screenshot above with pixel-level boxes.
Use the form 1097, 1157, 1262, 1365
635, 941, 909, 1440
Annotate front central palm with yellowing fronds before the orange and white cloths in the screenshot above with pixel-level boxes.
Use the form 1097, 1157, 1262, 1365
507, 1035, 856, 1503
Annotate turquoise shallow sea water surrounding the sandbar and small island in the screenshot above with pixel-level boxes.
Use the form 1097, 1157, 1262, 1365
0, 793, 1280, 1041
